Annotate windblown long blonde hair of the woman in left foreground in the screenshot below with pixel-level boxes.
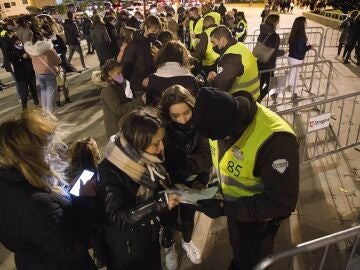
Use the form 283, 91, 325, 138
0, 109, 66, 193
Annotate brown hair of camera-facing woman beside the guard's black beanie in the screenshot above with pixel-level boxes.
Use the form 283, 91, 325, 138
159, 85, 195, 122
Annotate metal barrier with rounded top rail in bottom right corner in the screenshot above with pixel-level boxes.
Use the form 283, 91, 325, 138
253, 226, 360, 270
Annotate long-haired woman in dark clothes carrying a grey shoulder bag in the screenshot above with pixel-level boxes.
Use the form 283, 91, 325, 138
257, 14, 287, 102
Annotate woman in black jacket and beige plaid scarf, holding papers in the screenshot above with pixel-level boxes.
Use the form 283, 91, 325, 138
95, 109, 179, 270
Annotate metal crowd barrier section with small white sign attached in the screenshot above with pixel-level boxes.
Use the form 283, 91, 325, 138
278, 91, 360, 164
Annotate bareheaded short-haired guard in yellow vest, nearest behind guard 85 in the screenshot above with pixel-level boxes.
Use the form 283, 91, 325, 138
207, 25, 260, 100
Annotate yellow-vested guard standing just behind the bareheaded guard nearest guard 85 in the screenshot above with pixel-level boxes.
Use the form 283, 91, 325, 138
191, 16, 220, 75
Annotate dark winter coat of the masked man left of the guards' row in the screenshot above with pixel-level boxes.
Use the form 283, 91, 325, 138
121, 31, 159, 92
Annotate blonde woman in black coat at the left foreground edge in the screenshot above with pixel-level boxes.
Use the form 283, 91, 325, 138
0, 109, 96, 270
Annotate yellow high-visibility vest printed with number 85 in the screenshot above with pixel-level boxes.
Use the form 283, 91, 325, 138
209, 104, 295, 201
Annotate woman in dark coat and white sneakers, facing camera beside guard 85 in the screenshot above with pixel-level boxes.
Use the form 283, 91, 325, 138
160, 85, 212, 269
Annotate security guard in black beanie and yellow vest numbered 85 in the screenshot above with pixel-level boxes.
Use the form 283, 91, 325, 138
192, 88, 299, 270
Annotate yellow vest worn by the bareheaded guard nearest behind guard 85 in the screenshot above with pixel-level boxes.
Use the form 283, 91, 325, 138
222, 42, 260, 100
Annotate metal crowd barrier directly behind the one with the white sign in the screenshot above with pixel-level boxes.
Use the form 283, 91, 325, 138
259, 59, 333, 111
